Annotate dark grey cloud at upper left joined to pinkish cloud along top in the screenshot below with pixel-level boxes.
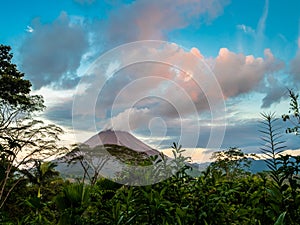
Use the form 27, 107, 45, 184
20, 0, 228, 89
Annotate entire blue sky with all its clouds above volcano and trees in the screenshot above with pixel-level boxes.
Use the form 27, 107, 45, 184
0, 0, 300, 160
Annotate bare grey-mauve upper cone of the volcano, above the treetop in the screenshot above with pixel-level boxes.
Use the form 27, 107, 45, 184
84, 130, 159, 156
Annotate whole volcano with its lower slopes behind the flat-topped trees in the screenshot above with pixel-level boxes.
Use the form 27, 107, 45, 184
57, 130, 160, 178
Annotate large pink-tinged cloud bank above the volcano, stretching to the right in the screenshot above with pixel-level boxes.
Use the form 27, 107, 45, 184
77, 42, 284, 132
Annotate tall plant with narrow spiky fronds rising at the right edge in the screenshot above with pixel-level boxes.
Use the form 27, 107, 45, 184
260, 113, 300, 224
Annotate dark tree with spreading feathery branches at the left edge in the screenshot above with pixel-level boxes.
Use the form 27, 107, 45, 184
0, 45, 66, 209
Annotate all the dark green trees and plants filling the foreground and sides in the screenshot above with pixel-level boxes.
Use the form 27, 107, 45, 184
0, 45, 300, 225
